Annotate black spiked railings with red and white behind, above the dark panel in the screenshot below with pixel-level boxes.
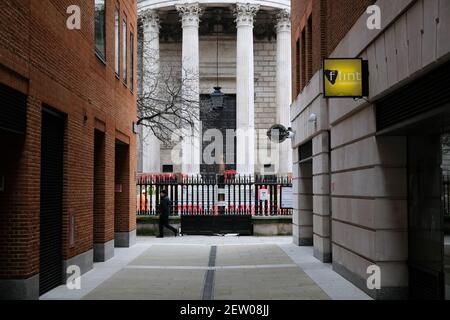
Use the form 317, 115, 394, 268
137, 174, 292, 216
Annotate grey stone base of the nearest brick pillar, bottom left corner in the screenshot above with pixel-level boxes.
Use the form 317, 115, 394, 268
0, 274, 39, 300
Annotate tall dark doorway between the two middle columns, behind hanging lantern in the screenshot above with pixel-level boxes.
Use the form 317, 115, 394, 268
200, 95, 236, 175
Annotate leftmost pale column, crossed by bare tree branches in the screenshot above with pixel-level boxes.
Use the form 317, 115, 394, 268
140, 10, 161, 173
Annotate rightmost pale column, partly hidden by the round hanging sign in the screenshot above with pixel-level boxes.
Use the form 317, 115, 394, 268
276, 10, 292, 175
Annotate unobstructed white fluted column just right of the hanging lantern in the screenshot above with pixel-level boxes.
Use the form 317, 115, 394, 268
235, 3, 259, 174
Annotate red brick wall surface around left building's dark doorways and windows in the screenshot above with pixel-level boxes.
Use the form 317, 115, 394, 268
0, 0, 137, 278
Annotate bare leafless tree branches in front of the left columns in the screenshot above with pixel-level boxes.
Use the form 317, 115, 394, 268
137, 39, 209, 147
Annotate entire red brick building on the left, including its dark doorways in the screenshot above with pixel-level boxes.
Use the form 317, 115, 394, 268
0, 0, 137, 299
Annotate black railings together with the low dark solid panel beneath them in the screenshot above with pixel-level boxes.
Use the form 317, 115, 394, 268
137, 174, 292, 234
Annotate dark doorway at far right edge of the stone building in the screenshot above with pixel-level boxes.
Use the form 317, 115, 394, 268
408, 133, 445, 299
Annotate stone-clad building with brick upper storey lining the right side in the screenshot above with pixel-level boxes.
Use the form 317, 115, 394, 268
291, 0, 450, 299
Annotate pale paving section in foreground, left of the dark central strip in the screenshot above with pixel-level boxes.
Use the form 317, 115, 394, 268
83, 269, 205, 300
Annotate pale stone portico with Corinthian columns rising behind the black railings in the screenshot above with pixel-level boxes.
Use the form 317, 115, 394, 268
138, 0, 291, 174
